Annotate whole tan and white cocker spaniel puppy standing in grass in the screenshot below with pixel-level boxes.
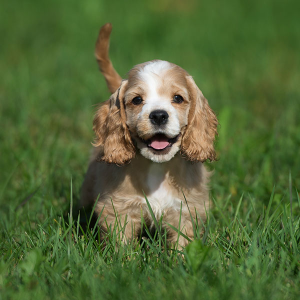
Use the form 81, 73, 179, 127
81, 24, 218, 247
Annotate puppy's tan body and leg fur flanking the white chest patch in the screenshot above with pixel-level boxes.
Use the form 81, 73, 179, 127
81, 154, 211, 246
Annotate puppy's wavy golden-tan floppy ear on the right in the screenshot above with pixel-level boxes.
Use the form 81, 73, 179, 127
181, 76, 218, 162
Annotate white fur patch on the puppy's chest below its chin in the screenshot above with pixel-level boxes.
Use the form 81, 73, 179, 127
146, 163, 181, 218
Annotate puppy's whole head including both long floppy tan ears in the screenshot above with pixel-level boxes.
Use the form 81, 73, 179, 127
93, 60, 218, 165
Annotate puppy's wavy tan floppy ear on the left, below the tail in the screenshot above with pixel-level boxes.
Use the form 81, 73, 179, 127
93, 80, 135, 165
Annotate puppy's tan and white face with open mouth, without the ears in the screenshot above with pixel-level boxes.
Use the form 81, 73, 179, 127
124, 61, 190, 162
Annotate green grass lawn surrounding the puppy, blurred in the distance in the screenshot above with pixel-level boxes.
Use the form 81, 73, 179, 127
0, 0, 300, 300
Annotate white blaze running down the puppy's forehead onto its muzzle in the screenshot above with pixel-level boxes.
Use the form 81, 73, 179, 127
139, 60, 180, 136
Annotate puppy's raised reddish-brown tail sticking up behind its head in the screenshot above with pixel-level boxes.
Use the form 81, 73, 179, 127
95, 23, 122, 93
